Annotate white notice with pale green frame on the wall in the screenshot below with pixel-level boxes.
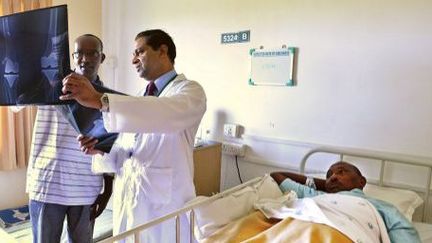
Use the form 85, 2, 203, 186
249, 47, 296, 86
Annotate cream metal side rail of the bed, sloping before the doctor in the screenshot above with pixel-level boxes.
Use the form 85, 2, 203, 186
99, 177, 262, 243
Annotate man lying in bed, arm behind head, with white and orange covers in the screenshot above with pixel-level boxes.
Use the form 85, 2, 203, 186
206, 162, 421, 243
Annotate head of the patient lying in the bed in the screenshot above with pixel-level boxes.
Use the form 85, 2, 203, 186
325, 161, 366, 193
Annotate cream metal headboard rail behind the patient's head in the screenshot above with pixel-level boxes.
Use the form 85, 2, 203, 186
300, 147, 432, 222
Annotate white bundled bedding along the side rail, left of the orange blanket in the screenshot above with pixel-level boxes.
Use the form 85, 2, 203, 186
188, 175, 283, 240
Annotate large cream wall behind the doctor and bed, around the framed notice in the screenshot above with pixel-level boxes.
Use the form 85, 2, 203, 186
98, 0, 432, 188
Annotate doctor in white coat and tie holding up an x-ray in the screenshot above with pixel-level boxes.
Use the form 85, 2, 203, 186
60, 30, 206, 243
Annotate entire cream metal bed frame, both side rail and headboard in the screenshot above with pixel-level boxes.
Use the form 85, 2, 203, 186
100, 147, 432, 243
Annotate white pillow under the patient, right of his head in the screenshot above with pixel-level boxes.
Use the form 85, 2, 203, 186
363, 184, 423, 221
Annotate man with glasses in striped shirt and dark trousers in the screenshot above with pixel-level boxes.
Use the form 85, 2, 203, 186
27, 34, 112, 243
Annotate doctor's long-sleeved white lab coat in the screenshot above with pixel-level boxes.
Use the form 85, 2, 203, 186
93, 74, 206, 243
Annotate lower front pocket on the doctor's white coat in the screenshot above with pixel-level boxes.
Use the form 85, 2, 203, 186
142, 167, 173, 204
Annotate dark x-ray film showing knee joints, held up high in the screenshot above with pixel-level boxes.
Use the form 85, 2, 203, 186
0, 5, 71, 105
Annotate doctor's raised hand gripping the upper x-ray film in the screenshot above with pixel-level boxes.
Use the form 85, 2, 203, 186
60, 73, 102, 109
